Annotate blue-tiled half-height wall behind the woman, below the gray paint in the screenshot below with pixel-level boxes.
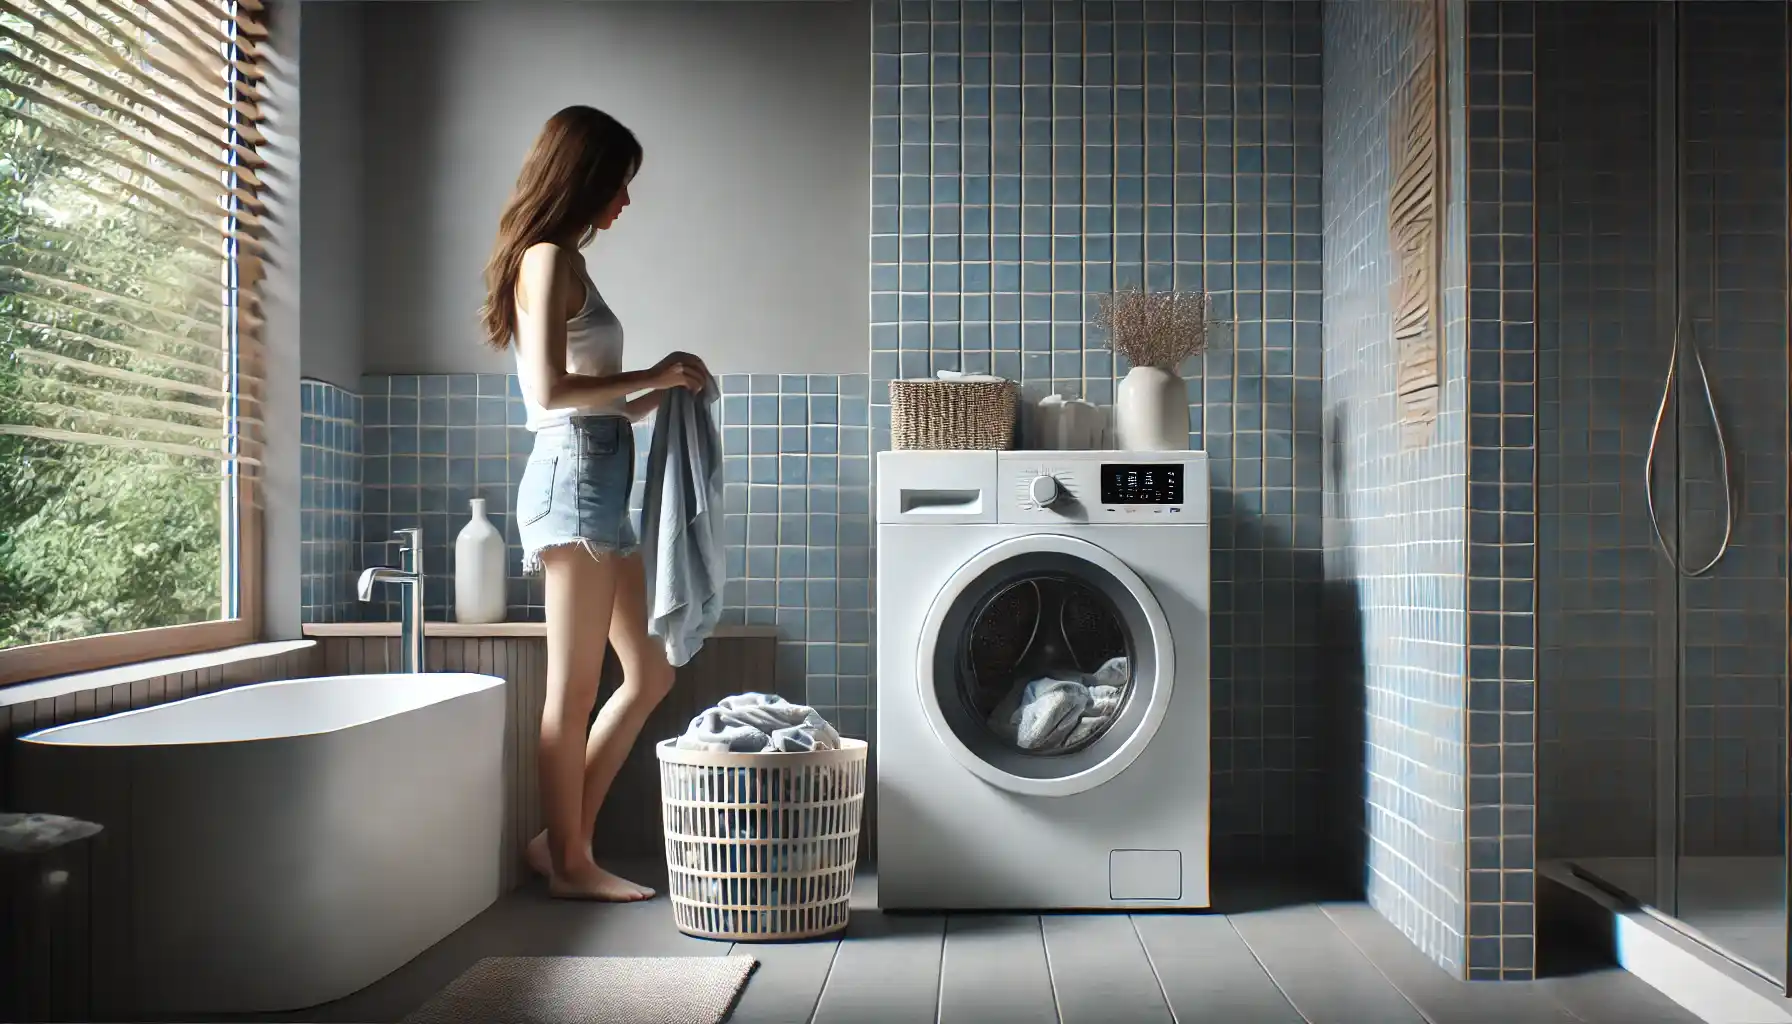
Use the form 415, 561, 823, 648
344, 373, 871, 735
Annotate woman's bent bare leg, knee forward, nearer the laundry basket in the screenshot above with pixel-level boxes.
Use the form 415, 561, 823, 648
529, 556, 676, 898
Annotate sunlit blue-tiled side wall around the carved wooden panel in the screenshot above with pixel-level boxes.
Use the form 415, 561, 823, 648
1324, 0, 1468, 974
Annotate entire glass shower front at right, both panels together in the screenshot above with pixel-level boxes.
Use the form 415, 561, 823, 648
1534, 2, 1792, 979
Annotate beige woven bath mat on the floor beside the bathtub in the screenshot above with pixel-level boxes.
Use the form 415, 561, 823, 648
403, 956, 758, 1024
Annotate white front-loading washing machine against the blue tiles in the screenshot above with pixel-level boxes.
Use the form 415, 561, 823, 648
876, 452, 1210, 909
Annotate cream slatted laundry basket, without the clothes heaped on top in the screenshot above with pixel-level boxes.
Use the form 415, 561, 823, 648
654, 739, 867, 942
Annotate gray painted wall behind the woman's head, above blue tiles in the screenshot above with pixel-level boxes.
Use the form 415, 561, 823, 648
354, 0, 871, 373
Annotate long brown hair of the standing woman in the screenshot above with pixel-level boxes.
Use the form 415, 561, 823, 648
478, 106, 642, 350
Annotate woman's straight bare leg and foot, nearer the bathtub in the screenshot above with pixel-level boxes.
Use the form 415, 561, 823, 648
532, 547, 643, 900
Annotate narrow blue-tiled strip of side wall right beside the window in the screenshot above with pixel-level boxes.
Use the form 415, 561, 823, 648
299, 380, 362, 622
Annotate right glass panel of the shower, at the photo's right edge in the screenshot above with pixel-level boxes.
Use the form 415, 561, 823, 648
1658, 2, 1788, 981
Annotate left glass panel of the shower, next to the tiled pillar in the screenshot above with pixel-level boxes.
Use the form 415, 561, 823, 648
1536, 2, 1679, 906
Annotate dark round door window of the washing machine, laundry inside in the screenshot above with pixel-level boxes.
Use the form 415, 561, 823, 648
959, 574, 1133, 757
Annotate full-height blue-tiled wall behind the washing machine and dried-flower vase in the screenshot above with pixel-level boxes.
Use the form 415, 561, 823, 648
871, 0, 1324, 857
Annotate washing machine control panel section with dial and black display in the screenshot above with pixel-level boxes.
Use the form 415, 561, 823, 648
996, 452, 1208, 525
